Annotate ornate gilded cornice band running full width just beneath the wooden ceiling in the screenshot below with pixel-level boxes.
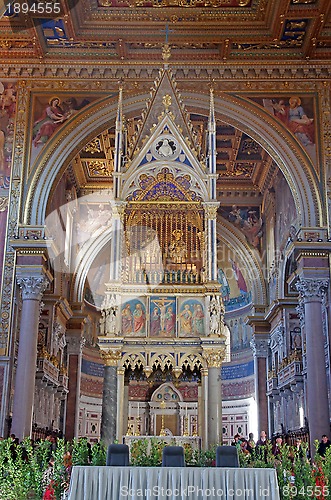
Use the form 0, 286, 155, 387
0, 65, 331, 81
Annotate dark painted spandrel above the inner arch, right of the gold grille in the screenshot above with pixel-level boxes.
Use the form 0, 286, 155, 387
219, 205, 263, 249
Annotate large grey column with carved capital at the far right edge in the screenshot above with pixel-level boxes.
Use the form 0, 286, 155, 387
296, 277, 330, 454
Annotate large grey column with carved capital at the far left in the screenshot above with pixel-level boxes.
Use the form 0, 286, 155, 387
11, 275, 49, 440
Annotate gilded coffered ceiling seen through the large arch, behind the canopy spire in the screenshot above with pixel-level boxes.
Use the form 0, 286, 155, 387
73, 113, 272, 203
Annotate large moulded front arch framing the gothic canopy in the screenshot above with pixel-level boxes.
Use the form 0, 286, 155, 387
22, 90, 325, 227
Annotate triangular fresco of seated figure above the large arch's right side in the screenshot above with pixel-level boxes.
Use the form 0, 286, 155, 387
251, 94, 316, 159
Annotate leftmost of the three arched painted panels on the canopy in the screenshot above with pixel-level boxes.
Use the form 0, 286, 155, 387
121, 299, 146, 337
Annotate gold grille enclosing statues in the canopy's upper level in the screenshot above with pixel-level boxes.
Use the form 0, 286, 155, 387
123, 202, 205, 283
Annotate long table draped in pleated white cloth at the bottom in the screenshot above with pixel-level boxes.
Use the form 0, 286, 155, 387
68, 466, 279, 500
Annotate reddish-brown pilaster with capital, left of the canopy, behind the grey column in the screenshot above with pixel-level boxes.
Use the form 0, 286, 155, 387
65, 329, 85, 440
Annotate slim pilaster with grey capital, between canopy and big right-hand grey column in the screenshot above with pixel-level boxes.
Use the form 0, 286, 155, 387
251, 333, 268, 435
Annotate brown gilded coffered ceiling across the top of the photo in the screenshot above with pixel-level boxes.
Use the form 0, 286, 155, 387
0, 0, 331, 65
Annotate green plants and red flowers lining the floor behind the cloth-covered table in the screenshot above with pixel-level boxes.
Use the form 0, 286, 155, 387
0, 437, 331, 500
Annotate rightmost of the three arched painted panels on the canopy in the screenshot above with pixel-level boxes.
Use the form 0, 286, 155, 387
178, 299, 205, 337
